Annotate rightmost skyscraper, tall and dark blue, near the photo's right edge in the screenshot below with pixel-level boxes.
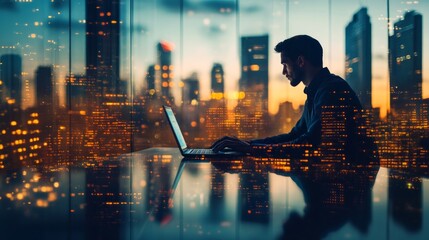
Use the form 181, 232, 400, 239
389, 11, 422, 120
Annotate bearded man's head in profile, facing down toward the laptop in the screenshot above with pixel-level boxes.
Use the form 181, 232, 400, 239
274, 35, 323, 86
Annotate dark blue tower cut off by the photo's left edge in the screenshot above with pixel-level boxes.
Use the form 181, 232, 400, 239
0, 54, 22, 108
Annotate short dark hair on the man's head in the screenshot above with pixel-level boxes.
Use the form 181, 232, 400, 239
274, 35, 323, 67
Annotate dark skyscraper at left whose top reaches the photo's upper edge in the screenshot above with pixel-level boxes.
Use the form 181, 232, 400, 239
86, 0, 120, 97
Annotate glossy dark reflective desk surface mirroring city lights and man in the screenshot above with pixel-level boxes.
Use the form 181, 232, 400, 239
0, 148, 429, 239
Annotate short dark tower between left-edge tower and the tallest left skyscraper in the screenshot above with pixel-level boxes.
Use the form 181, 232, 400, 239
36, 66, 53, 106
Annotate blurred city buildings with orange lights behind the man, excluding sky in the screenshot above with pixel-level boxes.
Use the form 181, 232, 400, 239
0, 1, 429, 172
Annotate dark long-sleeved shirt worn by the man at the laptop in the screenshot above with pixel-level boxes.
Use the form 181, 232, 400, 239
250, 68, 362, 148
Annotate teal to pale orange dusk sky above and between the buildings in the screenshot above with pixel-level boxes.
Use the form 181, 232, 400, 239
0, 0, 429, 115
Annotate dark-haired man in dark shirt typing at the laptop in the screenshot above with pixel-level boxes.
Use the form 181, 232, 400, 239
212, 35, 362, 158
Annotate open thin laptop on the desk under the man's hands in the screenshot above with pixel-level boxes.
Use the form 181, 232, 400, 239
163, 106, 245, 158
